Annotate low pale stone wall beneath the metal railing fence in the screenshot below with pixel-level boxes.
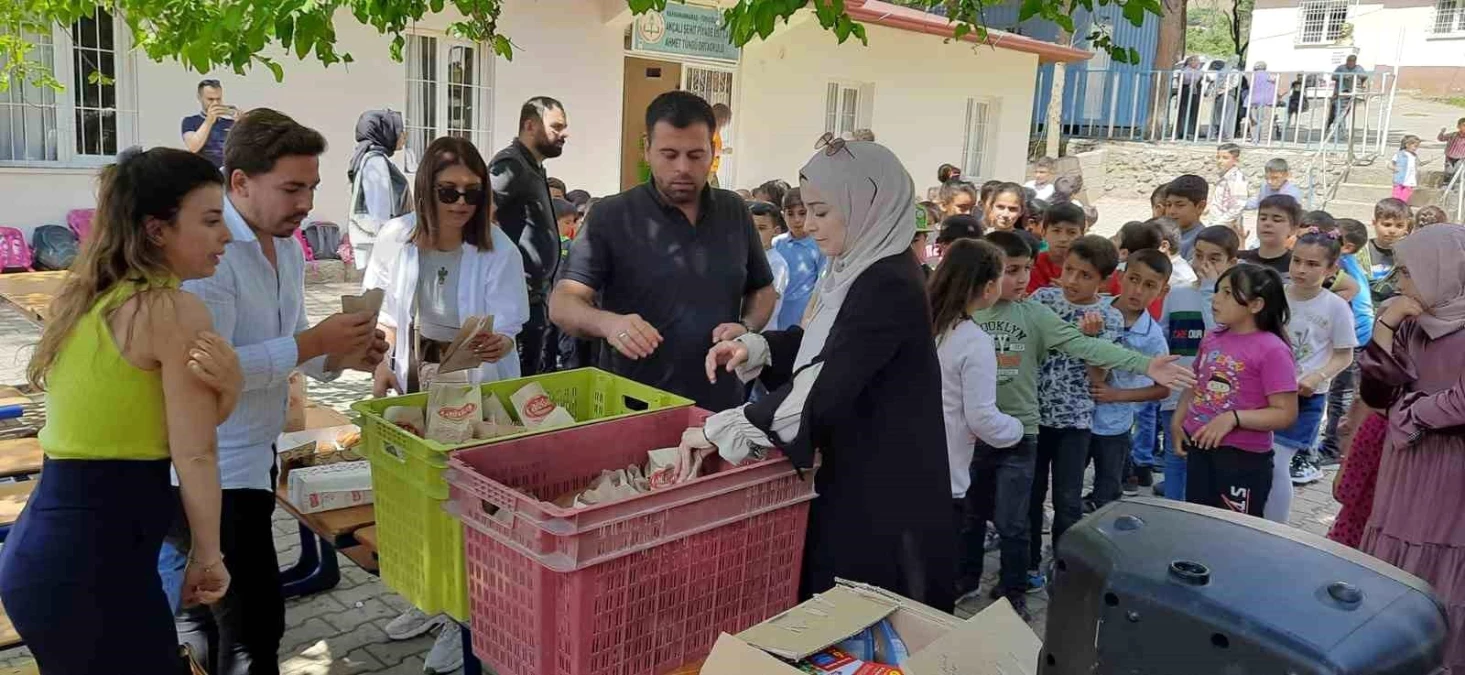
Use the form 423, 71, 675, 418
1069, 139, 1343, 205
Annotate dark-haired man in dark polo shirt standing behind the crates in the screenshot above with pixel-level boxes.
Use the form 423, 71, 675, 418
549, 91, 776, 410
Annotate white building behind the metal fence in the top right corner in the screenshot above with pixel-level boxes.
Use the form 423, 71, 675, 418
1247, 0, 1465, 94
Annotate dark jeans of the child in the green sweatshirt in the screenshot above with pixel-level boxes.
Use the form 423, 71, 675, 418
958, 436, 1042, 593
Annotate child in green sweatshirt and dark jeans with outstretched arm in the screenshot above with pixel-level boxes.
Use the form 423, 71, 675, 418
960, 231, 1194, 614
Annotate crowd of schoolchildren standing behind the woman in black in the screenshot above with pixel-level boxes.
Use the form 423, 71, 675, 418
732, 143, 1444, 626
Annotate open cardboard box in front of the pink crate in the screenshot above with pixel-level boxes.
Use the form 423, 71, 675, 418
702, 580, 1042, 675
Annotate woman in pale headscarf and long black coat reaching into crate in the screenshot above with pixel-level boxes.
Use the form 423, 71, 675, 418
684, 141, 955, 612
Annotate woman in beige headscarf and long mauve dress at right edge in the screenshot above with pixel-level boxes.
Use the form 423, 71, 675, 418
1358, 224, 1465, 674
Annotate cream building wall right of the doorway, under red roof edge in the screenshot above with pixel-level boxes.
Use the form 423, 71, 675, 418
734, 20, 1037, 195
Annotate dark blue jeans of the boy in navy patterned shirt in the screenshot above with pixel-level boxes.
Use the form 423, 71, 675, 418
1027, 426, 1091, 567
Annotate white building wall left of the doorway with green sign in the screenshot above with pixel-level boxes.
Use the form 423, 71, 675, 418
0, 0, 623, 231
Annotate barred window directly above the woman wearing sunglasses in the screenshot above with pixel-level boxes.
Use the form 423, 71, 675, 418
403, 35, 494, 165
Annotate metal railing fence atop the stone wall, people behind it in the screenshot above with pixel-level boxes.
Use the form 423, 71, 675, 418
1033, 69, 1398, 155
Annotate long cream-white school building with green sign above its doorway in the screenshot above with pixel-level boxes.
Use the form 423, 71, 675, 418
0, 0, 1088, 231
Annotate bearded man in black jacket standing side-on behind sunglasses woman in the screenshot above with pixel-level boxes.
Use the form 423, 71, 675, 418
488, 97, 570, 376
